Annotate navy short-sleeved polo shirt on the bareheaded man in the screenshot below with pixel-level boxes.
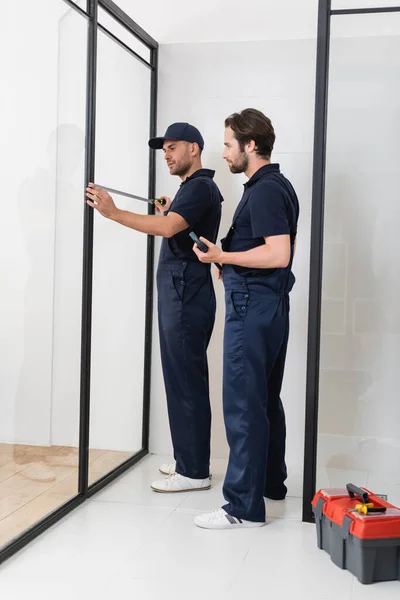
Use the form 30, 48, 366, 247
223, 164, 299, 275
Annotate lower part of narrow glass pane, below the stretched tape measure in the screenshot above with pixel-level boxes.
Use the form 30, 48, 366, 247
89, 194, 148, 482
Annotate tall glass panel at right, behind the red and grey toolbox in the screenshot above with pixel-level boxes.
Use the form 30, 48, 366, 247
317, 13, 400, 504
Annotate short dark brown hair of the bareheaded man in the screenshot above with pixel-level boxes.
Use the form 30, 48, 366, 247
225, 108, 275, 158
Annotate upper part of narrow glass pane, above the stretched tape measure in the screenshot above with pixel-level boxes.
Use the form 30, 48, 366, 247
96, 31, 151, 196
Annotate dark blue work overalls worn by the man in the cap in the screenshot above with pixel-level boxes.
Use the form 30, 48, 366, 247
157, 169, 222, 479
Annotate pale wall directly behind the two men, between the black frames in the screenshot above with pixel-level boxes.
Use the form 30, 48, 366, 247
150, 40, 316, 493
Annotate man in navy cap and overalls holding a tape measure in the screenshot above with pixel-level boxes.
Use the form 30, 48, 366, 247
87, 123, 223, 493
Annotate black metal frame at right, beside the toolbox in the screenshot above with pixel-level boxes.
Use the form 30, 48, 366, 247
303, 0, 400, 523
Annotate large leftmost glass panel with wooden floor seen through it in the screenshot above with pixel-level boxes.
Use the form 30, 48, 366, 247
0, 0, 87, 546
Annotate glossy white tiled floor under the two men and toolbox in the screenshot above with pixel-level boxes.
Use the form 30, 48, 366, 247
4, 456, 394, 600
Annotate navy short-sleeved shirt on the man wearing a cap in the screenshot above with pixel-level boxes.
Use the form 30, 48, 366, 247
160, 169, 223, 262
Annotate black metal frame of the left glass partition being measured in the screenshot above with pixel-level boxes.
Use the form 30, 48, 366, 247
0, 0, 158, 563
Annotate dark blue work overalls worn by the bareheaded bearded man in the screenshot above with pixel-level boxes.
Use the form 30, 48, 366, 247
222, 168, 298, 522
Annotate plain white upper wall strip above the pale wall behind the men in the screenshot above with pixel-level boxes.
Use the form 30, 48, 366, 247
118, 0, 318, 44
